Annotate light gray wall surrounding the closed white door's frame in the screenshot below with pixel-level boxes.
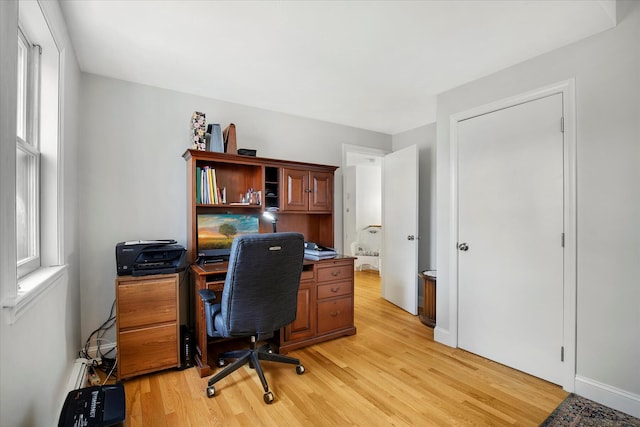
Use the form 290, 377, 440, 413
436, 1, 640, 416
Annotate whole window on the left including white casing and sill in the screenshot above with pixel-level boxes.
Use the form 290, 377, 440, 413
0, 0, 66, 323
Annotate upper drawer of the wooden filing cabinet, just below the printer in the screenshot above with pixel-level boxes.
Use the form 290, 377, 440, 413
117, 277, 178, 330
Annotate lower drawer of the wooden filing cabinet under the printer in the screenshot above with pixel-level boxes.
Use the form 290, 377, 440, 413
118, 322, 179, 378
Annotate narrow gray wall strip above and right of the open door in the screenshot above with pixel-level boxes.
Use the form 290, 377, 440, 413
393, 123, 436, 274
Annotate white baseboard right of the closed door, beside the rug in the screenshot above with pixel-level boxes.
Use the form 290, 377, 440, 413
575, 375, 640, 418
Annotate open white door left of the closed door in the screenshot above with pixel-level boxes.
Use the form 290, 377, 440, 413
381, 145, 418, 315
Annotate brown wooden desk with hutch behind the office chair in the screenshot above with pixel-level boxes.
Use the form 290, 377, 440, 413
183, 150, 356, 376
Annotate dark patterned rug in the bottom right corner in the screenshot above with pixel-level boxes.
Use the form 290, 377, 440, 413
540, 393, 640, 427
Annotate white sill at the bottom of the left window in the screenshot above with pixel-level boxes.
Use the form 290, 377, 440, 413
2, 265, 67, 324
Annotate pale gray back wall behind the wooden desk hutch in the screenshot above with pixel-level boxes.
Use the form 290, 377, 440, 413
79, 74, 391, 348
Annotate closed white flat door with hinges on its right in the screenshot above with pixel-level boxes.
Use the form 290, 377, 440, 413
458, 94, 563, 384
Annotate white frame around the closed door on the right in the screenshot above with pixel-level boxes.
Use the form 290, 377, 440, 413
449, 79, 577, 392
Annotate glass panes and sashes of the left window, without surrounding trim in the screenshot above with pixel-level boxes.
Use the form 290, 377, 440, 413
16, 29, 41, 280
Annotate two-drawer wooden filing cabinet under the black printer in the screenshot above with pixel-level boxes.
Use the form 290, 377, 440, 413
116, 273, 180, 379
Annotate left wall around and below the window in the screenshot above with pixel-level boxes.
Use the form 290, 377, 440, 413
0, 0, 81, 426
